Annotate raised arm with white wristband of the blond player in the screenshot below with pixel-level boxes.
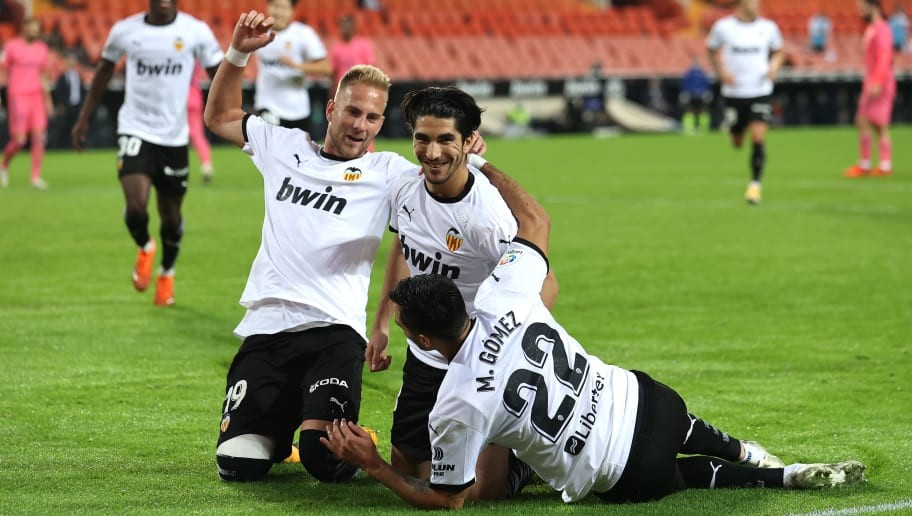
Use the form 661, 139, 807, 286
204, 11, 275, 147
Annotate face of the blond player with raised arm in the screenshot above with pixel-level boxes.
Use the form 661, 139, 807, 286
323, 82, 387, 159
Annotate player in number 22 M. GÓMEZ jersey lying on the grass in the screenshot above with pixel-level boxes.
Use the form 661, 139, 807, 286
322, 153, 865, 509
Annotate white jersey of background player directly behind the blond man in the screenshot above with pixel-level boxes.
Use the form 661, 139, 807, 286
254, 22, 327, 120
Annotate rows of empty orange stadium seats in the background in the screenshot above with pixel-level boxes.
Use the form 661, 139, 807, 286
0, 0, 912, 81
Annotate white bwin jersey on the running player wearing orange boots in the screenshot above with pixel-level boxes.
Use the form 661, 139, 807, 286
101, 12, 224, 147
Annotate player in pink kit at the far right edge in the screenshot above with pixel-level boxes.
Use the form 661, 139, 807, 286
845, 0, 896, 178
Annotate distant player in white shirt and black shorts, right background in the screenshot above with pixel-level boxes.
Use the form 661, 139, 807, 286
706, 0, 785, 204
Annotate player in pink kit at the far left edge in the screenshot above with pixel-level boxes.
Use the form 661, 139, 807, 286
0, 18, 53, 190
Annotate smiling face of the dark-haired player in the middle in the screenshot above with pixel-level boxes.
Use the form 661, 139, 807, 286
412, 115, 469, 193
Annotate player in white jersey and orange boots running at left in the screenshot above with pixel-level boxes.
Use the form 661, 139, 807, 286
72, 0, 223, 306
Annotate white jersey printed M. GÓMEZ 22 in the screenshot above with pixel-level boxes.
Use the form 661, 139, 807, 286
429, 239, 639, 502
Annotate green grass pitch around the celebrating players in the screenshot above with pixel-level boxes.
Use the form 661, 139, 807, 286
0, 127, 912, 514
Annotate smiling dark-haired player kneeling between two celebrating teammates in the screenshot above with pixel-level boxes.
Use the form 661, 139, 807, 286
367, 87, 557, 499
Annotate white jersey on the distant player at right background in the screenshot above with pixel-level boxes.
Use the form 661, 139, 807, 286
706, 15, 782, 99
